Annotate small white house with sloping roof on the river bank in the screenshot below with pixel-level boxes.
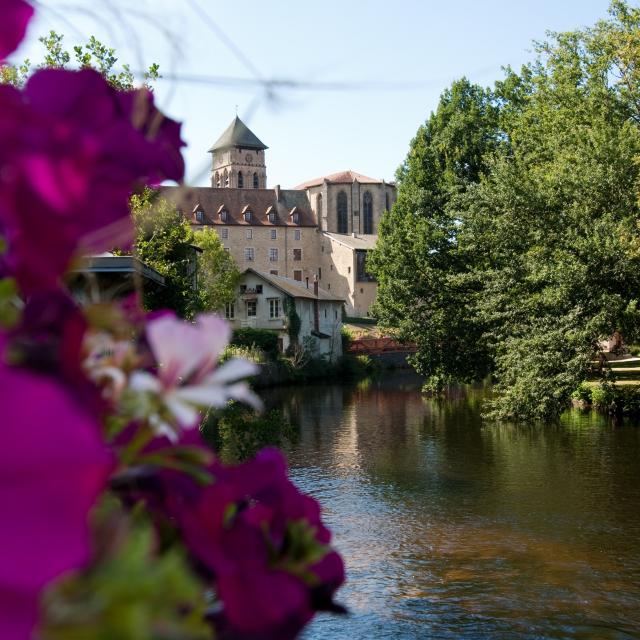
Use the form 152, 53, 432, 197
225, 269, 344, 361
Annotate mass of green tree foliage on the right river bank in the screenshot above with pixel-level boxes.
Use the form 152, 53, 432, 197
369, 1, 640, 419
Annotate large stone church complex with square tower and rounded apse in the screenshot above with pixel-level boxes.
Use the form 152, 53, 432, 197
162, 116, 396, 318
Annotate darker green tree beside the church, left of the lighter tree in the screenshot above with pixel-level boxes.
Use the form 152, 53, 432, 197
367, 78, 501, 391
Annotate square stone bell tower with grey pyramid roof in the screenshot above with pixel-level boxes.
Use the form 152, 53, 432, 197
209, 116, 268, 189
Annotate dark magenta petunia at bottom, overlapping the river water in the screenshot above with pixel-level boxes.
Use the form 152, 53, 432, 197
165, 449, 344, 640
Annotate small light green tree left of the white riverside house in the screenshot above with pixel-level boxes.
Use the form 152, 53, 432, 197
194, 227, 240, 311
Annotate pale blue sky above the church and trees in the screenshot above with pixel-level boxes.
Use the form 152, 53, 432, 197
14, 0, 609, 187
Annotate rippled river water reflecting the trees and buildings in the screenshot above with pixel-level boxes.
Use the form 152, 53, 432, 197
272, 374, 640, 640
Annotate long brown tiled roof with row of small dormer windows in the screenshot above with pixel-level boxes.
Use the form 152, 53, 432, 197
160, 187, 317, 227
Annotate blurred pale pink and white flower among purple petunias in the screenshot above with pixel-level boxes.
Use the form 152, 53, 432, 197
129, 314, 261, 439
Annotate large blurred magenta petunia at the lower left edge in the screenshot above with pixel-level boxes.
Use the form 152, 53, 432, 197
0, 363, 112, 640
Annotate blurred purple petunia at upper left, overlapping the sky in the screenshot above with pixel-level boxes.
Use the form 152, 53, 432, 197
0, 69, 184, 293
